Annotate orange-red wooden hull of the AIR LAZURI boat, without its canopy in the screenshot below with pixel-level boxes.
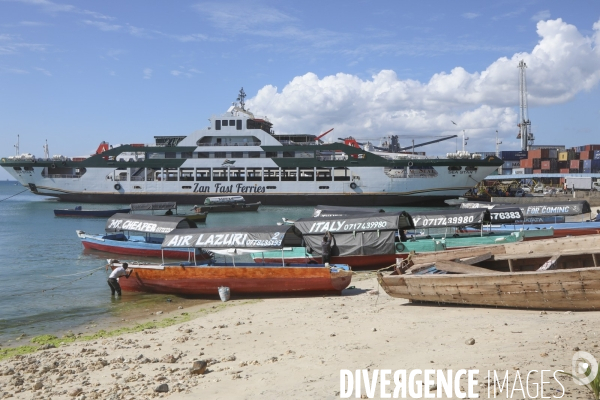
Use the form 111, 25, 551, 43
113, 264, 352, 296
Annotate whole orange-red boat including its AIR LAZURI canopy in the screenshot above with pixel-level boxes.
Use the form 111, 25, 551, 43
108, 225, 352, 297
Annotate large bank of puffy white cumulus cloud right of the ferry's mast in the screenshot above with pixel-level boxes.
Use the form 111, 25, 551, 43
247, 19, 600, 148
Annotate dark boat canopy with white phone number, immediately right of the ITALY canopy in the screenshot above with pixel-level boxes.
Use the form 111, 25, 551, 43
410, 208, 490, 228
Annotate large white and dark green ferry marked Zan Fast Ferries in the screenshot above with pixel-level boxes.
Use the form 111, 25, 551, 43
0, 90, 502, 206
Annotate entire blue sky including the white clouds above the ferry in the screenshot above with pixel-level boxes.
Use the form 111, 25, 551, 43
0, 0, 600, 179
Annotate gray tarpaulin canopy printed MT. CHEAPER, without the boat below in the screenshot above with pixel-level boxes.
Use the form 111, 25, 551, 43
106, 213, 196, 233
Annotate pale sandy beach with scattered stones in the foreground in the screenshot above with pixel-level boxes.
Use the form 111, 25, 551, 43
0, 273, 600, 399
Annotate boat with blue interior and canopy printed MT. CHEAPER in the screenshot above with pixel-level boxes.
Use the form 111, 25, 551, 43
77, 214, 209, 259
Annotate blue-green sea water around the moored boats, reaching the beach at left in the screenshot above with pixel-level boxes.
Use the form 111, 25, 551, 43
0, 181, 432, 347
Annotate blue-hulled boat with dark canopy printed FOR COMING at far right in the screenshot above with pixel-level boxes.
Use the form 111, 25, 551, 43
461, 200, 600, 237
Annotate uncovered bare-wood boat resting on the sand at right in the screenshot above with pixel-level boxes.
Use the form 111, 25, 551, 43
377, 235, 600, 311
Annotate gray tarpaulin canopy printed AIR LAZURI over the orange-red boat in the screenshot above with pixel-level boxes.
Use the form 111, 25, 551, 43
162, 225, 302, 253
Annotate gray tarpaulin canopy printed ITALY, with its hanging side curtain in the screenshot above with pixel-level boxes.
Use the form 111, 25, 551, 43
294, 212, 413, 256
